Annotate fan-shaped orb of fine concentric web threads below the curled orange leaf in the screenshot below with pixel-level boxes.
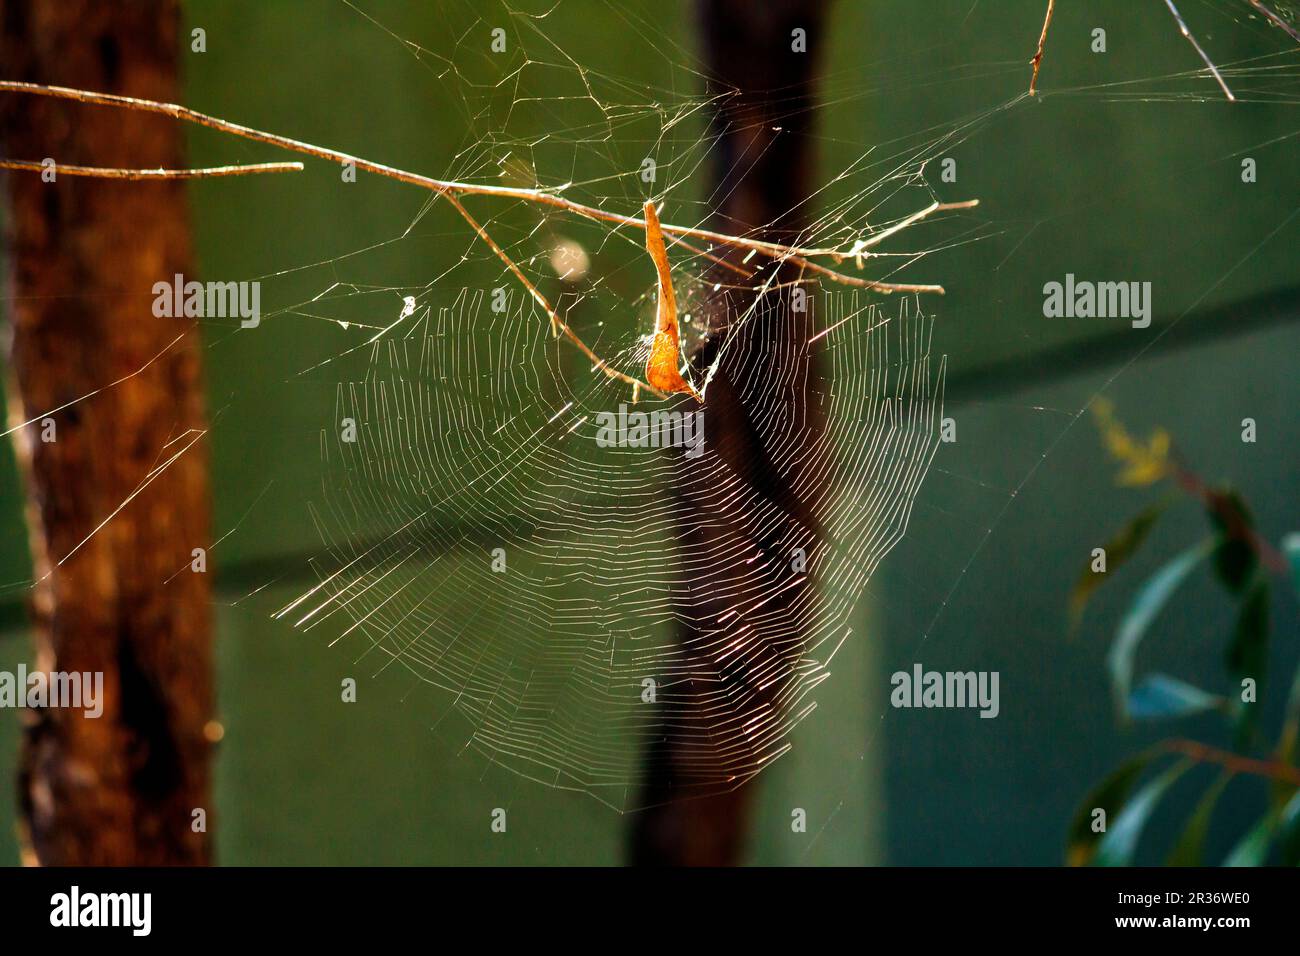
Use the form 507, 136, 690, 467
276, 291, 943, 809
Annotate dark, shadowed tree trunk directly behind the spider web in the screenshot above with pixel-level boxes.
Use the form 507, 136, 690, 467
631, 0, 827, 865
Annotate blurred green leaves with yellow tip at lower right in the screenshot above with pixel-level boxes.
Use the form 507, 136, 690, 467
1066, 399, 1300, 866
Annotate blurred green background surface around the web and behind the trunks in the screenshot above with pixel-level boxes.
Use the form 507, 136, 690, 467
0, 0, 1300, 864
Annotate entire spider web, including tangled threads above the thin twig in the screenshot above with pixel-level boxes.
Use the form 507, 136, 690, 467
236, 4, 1295, 809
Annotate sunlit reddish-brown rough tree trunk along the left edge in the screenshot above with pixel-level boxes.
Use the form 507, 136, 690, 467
0, 0, 213, 865
